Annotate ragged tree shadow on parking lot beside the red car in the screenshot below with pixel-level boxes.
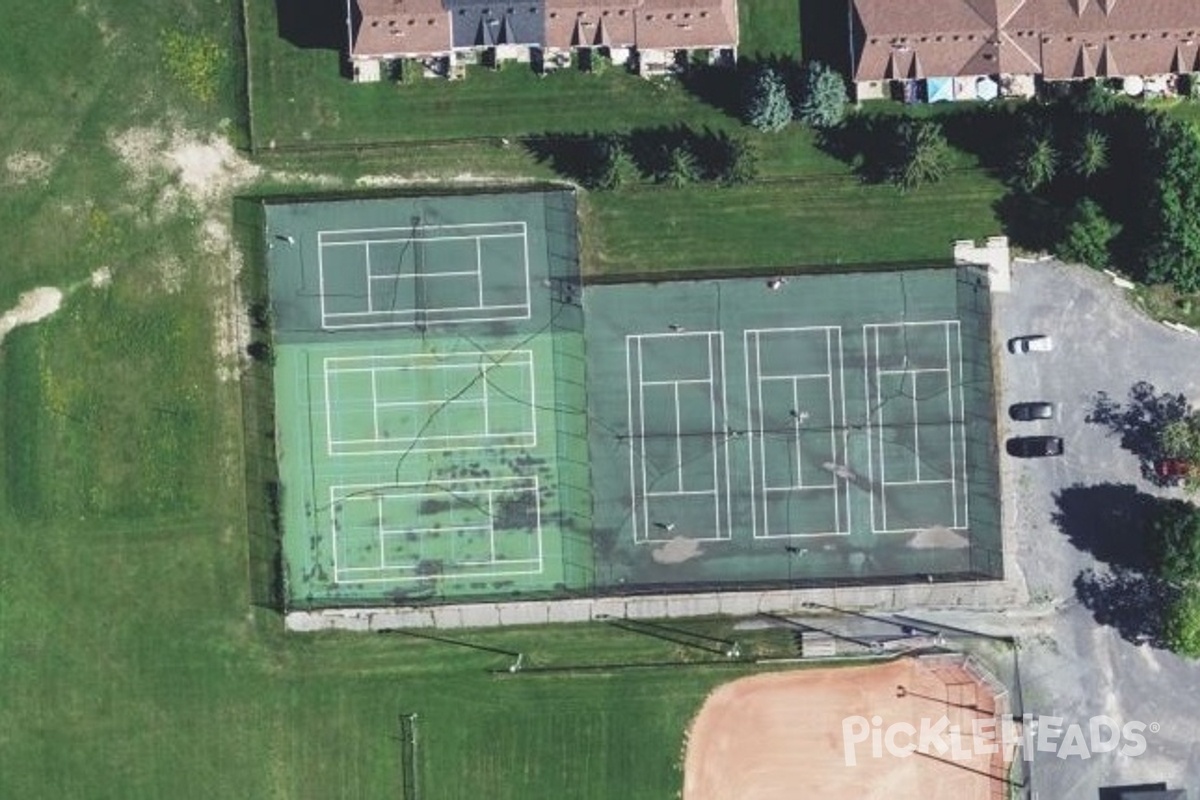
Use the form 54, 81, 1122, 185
1085, 380, 1189, 486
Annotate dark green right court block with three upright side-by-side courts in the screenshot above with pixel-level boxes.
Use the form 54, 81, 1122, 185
584, 267, 1001, 587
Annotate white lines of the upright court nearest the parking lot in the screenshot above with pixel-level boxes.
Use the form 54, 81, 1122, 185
863, 319, 968, 534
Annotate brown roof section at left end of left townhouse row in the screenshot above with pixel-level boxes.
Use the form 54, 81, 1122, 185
350, 0, 450, 58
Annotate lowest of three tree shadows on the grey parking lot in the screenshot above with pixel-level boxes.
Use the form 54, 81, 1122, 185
1075, 569, 1178, 648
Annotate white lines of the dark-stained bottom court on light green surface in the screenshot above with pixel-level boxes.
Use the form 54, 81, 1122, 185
329, 475, 546, 583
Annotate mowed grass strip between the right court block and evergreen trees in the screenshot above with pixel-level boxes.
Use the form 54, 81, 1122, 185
586, 170, 1004, 277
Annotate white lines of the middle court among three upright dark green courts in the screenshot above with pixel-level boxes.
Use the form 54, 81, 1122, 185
742, 325, 851, 539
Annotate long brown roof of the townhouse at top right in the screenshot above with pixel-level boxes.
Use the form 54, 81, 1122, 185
854, 0, 1200, 80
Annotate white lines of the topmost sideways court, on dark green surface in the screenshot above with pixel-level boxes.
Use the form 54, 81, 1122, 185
317, 219, 533, 330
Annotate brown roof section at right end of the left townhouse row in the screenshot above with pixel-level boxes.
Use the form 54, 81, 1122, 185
636, 0, 738, 50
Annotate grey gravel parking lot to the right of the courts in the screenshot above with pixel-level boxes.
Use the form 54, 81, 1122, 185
996, 261, 1200, 799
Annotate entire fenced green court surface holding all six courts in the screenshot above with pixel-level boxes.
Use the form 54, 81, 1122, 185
265, 193, 1001, 606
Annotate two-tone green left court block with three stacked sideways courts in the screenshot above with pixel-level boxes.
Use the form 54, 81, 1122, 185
265, 194, 590, 606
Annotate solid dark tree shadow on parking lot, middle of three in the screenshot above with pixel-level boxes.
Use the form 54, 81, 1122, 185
1051, 483, 1160, 571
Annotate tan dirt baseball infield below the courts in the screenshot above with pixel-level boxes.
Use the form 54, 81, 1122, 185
683, 658, 1013, 800
